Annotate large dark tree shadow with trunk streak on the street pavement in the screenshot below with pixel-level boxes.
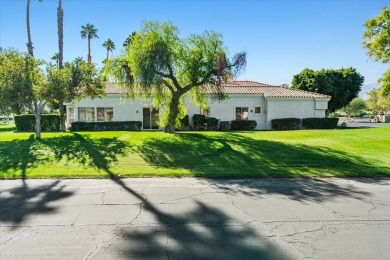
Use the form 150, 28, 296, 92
106, 175, 293, 259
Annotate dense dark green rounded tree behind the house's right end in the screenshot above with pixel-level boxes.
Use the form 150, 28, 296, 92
291, 68, 364, 113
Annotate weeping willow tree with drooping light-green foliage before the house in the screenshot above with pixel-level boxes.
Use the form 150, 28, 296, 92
106, 21, 246, 133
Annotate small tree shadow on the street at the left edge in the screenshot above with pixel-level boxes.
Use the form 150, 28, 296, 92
0, 180, 73, 229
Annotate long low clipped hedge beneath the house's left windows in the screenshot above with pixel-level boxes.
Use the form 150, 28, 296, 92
71, 121, 142, 131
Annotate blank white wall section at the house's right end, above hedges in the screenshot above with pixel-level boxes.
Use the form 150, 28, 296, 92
266, 98, 329, 129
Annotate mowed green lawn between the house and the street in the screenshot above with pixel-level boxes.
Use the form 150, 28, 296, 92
0, 124, 390, 179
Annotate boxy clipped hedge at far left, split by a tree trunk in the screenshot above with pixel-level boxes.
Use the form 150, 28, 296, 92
14, 114, 61, 132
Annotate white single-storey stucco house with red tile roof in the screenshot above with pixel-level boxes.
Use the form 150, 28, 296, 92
67, 81, 331, 130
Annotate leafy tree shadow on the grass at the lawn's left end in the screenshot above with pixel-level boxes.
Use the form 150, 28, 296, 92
0, 133, 129, 179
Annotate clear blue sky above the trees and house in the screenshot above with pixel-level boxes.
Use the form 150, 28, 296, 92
0, 0, 389, 85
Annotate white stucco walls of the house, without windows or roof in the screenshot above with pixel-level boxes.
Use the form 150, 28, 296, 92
67, 94, 329, 130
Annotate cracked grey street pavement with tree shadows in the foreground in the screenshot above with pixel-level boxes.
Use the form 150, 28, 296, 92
0, 178, 390, 260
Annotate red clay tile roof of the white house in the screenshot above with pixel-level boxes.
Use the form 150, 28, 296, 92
106, 81, 331, 99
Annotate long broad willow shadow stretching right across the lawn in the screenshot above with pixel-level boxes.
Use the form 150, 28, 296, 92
138, 133, 390, 177
